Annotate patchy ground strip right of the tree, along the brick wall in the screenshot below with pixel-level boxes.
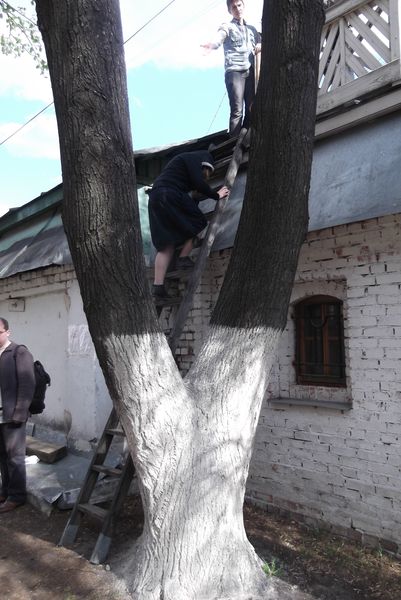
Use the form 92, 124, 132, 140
244, 505, 401, 600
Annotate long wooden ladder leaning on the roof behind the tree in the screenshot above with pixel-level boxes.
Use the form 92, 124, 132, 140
59, 129, 249, 564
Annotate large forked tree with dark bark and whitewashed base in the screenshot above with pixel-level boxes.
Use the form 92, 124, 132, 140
36, 0, 323, 600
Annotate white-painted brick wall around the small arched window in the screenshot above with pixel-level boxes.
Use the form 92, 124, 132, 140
179, 215, 401, 552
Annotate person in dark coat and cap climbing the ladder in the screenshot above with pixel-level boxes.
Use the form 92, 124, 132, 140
148, 150, 229, 298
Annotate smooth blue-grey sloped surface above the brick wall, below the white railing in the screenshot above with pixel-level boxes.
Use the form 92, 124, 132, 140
198, 112, 401, 250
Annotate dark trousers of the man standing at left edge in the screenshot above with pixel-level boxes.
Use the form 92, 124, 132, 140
0, 423, 26, 504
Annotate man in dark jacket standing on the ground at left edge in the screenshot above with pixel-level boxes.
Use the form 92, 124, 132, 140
0, 317, 35, 514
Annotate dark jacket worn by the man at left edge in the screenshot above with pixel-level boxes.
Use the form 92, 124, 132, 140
0, 342, 35, 422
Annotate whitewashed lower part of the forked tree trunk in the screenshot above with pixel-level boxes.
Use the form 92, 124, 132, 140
112, 327, 279, 600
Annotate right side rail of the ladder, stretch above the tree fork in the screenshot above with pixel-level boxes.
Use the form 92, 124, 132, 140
169, 128, 250, 353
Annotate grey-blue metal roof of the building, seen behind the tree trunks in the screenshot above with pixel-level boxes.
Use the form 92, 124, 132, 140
0, 111, 401, 278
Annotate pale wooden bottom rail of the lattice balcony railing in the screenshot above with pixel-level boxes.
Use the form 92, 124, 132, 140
316, 59, 401, 115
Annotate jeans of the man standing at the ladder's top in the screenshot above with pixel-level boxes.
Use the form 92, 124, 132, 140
225, 67, 255, 137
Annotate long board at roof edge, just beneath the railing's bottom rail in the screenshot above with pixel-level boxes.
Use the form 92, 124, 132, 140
315, 88, 401, 140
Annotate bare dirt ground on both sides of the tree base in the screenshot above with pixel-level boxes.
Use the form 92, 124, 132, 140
0, 497, 401, 600
